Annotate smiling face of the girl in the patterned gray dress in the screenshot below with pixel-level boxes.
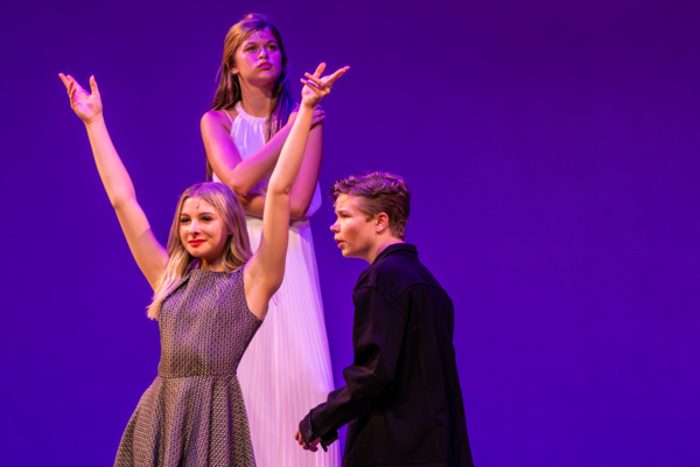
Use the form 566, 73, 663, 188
180, 197, 230, 270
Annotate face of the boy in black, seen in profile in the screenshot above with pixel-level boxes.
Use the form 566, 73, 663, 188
331, 194, 379, 263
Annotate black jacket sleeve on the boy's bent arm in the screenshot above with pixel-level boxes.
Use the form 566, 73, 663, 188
299, 287, 405, 444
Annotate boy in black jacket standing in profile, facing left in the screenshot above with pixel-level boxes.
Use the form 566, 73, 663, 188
296, 172, 473, 467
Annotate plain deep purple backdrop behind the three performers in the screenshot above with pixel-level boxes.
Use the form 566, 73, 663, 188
0, 0, 700, 467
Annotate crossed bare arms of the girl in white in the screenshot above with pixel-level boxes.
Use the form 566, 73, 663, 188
200, 108, 325, 219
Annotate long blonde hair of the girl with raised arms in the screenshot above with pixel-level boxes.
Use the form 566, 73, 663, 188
148, 182, 253, 319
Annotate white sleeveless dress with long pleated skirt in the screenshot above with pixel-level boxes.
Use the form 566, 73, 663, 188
214, 103, 340, 467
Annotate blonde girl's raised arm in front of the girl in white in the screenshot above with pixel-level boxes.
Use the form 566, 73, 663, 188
244, 63, 348, 318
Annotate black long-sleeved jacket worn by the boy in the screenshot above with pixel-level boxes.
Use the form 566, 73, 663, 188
299, 243, 473, 467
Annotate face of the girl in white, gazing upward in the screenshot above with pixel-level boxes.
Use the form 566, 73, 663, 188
231, 29, 282, 86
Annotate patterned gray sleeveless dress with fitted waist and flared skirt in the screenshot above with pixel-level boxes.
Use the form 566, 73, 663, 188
114, 268, 261, 467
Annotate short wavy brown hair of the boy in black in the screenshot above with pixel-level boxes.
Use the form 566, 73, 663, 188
331, 171, 411, 240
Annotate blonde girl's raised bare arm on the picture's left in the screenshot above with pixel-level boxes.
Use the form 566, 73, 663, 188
59, 73, 168, 289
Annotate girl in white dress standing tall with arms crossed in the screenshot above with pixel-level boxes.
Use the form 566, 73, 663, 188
201, 14, 340, 467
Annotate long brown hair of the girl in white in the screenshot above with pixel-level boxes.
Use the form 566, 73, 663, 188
207, 13, 294, 180
